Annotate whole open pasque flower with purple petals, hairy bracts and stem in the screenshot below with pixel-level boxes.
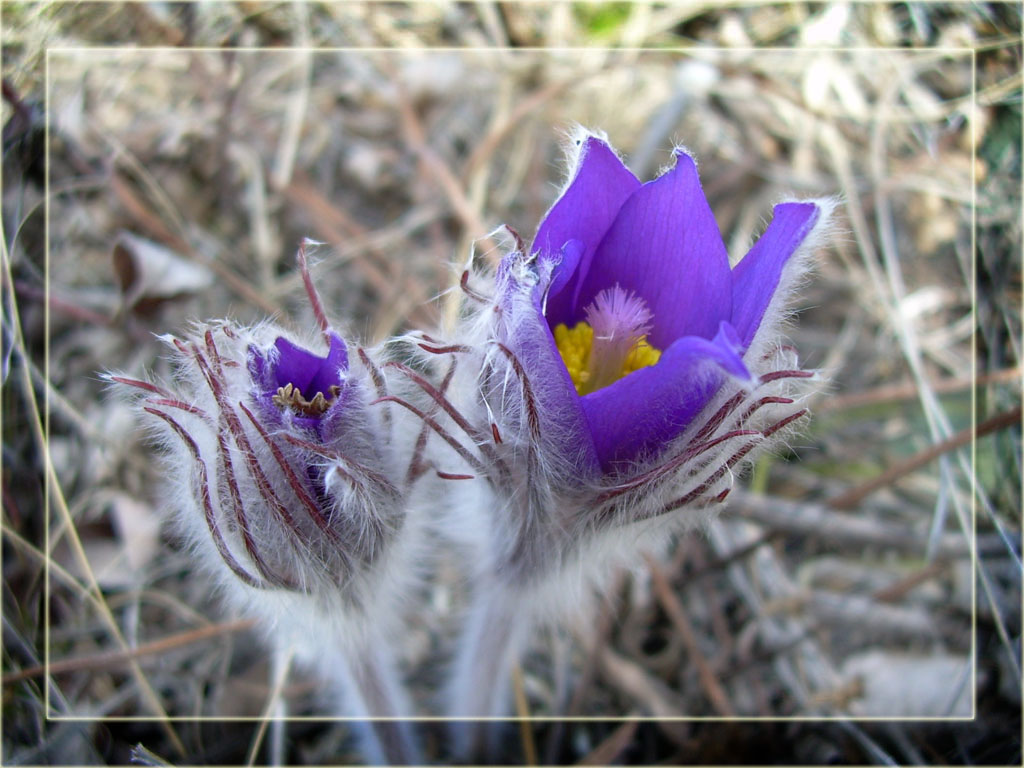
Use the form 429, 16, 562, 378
407, 128, 831, 746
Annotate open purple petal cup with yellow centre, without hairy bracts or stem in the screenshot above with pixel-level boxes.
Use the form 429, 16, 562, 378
497, 135, 821, 476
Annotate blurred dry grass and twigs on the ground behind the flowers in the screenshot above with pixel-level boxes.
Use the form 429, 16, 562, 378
0, 2, 1022, 765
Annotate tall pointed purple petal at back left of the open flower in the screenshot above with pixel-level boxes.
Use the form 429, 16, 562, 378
530, 136, 640, 325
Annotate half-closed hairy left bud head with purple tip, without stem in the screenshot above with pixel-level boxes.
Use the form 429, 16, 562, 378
112, 323, 402, 604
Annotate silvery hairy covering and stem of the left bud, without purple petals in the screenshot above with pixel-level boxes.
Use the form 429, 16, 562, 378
106, 321, 425, 741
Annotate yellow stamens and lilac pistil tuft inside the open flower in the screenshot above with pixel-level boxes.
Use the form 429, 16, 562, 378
554, 285, 662, 395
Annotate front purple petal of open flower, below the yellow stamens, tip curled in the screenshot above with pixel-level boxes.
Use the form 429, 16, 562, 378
581, 323, 751, 472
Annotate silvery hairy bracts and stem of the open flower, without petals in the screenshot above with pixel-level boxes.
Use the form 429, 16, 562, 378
411, 138, 836, 741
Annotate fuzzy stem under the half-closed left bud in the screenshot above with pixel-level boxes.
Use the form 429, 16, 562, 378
333, 643, 423, 765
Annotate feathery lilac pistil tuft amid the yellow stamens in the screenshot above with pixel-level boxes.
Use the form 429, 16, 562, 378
581, 283, 653, 394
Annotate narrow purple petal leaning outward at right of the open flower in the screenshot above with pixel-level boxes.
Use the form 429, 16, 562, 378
732, 203, 819, 349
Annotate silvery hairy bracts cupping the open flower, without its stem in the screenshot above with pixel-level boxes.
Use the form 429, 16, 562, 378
422, 201, 833, 602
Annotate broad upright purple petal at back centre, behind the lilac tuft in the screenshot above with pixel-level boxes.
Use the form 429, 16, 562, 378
575, 153, 732, 349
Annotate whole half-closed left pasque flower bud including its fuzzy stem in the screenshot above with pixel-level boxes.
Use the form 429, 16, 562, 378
109, 251, 419, 762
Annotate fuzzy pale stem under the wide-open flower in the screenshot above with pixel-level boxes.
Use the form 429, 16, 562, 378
449, 580, 532, 761
